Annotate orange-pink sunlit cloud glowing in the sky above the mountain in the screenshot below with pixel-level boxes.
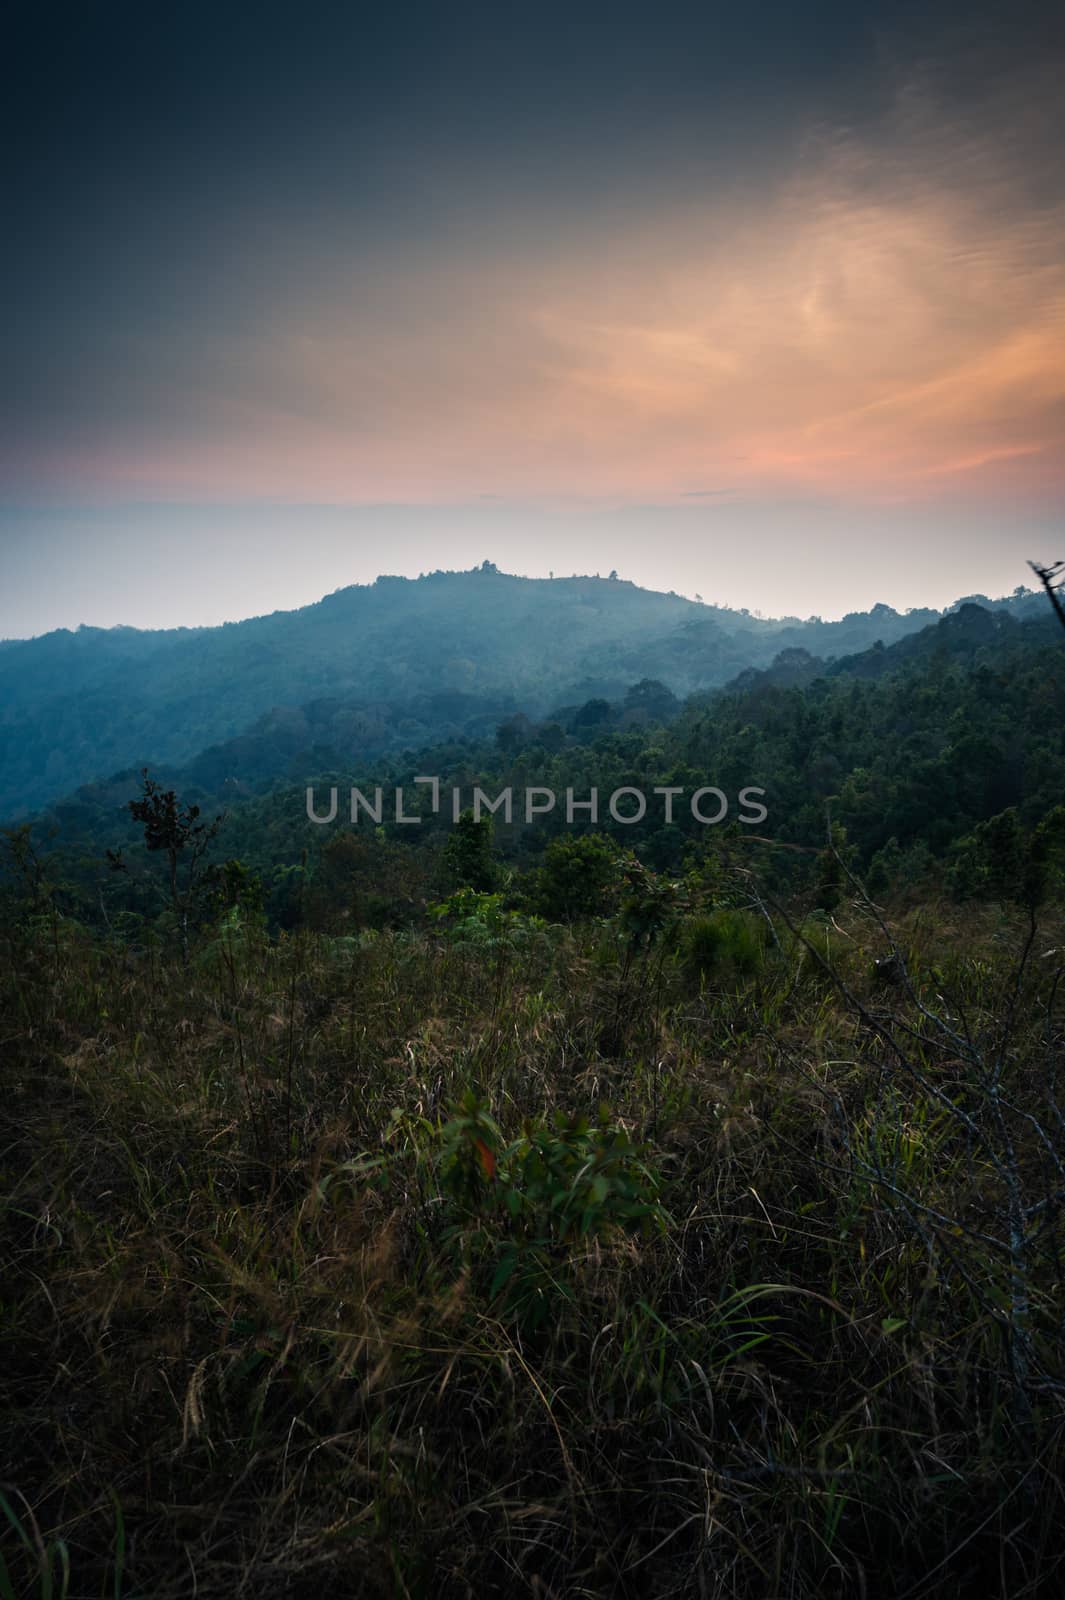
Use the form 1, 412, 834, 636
20, 62, 1065, 502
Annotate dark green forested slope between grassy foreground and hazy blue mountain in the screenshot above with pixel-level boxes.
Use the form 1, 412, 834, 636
14, 605, 1065, 931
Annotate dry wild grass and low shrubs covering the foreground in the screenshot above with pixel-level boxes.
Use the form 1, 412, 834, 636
0, 878, 1065, 1600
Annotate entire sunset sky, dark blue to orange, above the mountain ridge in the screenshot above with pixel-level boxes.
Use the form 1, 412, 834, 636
0, 0, 1065, 637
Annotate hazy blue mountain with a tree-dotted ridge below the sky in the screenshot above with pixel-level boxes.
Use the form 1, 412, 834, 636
0, 562, 1036, 821
